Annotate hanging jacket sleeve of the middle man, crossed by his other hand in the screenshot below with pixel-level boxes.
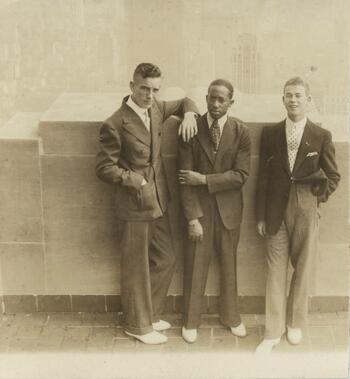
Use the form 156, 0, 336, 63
178, 138, 203, 221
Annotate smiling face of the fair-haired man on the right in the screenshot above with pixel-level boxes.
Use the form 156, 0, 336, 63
283, 85, 311, 121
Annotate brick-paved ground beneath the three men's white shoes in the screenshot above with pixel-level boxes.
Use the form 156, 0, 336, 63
0, 312, 348, 353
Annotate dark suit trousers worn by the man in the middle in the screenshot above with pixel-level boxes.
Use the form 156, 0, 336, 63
183, 205, 241, 329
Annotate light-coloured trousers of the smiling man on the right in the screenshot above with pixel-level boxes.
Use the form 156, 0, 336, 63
265, 184, 319, 339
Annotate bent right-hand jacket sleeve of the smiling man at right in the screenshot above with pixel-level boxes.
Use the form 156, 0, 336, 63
318, 130, 340, 202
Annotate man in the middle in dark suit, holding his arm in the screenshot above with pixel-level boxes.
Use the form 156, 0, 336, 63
178, 79, 250, 343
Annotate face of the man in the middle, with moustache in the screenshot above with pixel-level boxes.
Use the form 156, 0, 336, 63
206, 85, 233, 119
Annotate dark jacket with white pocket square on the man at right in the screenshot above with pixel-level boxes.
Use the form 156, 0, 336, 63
256, 120, 340, 234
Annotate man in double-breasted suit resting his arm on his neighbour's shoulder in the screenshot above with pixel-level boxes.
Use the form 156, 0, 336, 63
96, 63, 197, 344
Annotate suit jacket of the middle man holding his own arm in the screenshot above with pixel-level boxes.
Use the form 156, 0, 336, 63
178, 114, 250, 229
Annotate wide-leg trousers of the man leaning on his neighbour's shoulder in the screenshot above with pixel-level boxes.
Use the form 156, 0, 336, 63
118, 213, 175, 335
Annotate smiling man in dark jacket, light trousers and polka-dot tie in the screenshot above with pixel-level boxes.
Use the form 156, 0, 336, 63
256, 77, 340, 352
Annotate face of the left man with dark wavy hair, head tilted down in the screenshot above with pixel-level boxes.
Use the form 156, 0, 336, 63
130, 75, 162, 109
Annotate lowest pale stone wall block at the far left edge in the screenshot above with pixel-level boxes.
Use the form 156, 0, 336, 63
0, 244, 45, 295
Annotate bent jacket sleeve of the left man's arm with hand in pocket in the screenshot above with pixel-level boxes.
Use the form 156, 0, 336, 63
96, 122, 143, 190
